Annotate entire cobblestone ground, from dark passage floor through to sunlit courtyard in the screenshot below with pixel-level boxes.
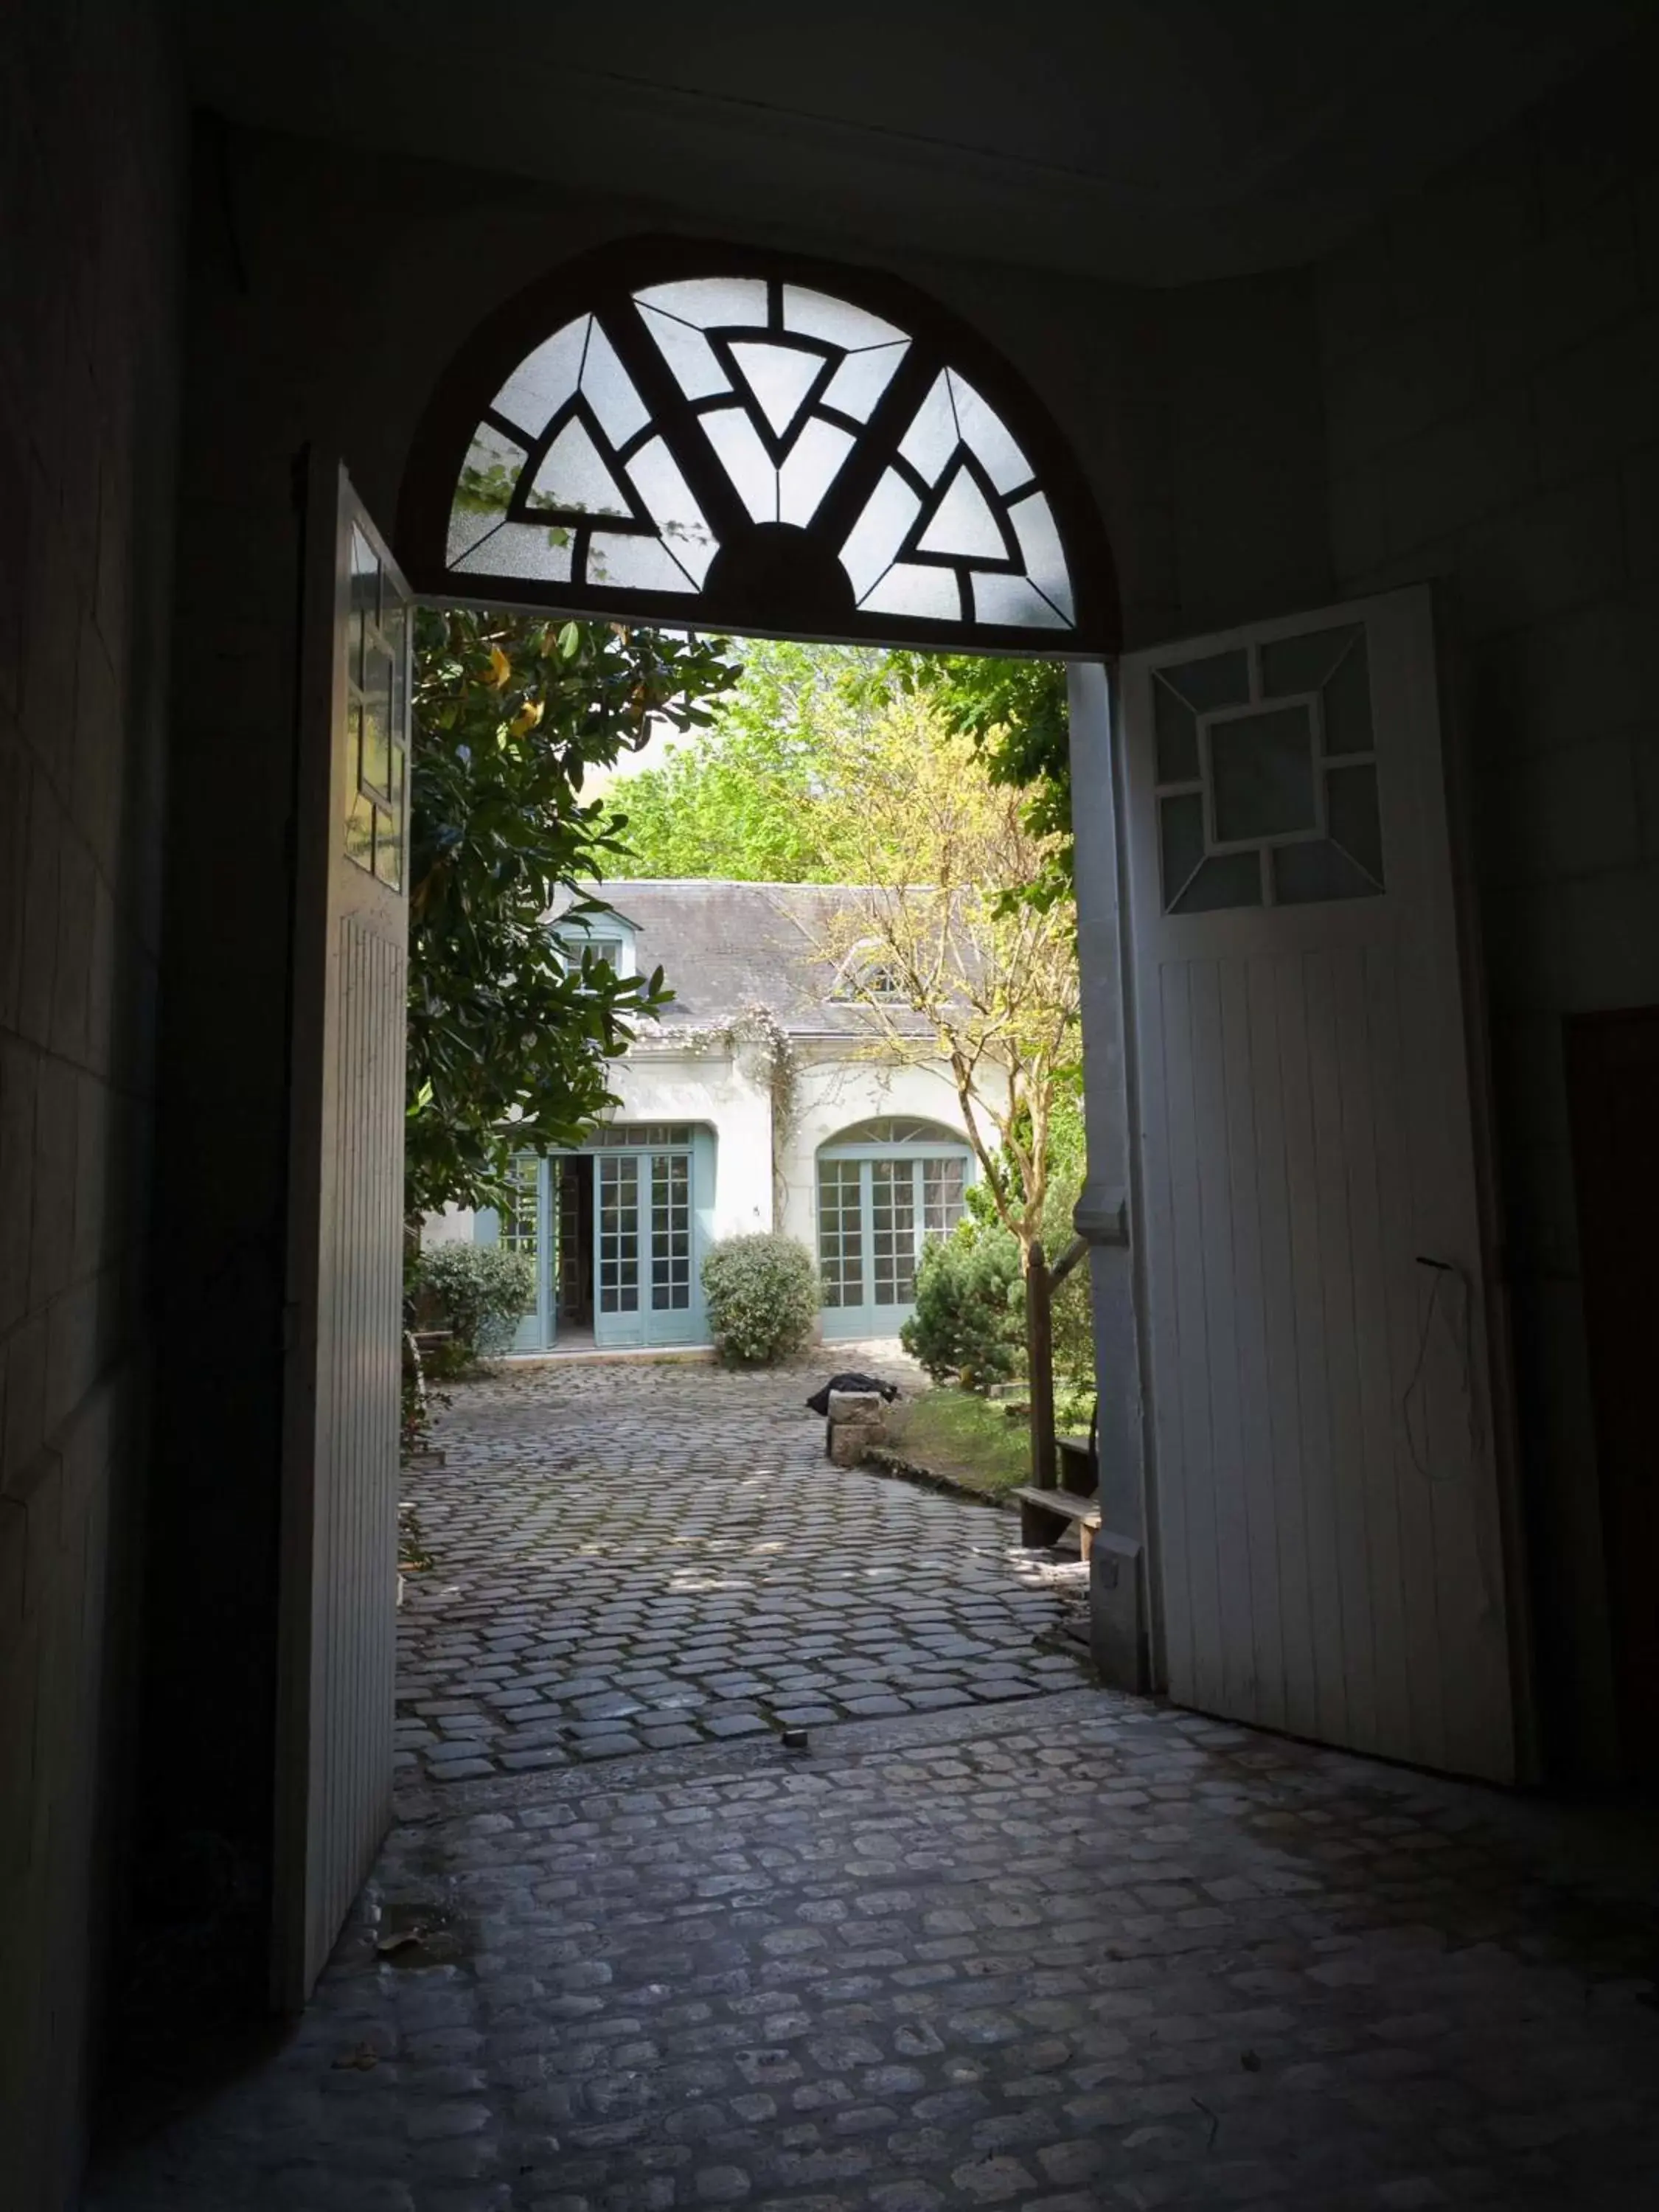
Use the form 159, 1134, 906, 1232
88, 1367, 1659, 2212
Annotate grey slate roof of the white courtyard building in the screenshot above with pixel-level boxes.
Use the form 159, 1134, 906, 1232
571, 880, 927, 1037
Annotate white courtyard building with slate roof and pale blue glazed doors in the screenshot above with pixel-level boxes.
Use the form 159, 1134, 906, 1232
422, 880, 998, 1352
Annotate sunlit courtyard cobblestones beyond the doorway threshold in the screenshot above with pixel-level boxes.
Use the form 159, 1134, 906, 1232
398, 1345, 1084, 1781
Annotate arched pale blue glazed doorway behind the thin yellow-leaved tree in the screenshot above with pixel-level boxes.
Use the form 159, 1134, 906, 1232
816, 1117, 973, 1343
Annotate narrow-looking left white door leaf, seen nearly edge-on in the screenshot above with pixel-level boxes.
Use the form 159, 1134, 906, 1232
272, 465, 411, 2008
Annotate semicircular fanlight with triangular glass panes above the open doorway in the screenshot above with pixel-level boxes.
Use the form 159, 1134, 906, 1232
400, 243, 1115, 653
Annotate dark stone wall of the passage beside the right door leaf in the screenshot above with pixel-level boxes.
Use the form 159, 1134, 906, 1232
1318, 38, 1659, 1770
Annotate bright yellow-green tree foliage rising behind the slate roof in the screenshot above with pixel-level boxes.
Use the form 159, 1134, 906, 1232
608, 644, 887, 883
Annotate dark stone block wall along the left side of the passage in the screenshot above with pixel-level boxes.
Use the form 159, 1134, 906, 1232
0, 0, 181, 2212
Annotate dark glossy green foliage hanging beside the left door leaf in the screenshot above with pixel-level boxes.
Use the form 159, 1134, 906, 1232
405, 608, 732, 1214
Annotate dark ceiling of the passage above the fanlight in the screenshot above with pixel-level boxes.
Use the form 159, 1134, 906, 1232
181, 0, 1648, 283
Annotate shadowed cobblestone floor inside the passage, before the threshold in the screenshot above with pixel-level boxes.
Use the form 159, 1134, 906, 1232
91, 1690, 1659, 2212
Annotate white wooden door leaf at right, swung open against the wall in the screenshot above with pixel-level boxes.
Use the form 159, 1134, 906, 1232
1119, 591, 1517, 1778
